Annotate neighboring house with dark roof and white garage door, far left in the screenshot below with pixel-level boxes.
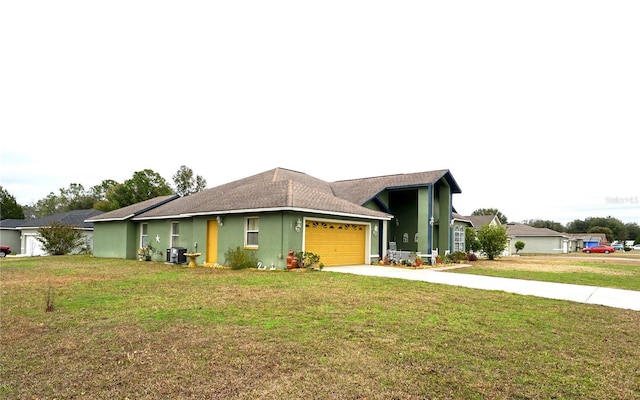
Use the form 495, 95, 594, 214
12, 209, 102, 256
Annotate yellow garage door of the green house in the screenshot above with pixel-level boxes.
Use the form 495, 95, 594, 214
304, 220, 367, 266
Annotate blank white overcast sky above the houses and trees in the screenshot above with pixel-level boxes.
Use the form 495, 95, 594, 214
0, 0, 640, 223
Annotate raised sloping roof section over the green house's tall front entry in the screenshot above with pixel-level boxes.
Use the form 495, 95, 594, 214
331, 169, 462, 204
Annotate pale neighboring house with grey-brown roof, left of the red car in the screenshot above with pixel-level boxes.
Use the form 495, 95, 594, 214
506, 222, 575, 255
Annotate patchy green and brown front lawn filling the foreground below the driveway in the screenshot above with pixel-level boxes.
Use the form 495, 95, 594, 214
0, 256, 640, 399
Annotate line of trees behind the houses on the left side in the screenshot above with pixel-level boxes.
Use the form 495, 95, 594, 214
0, 165, 207, 219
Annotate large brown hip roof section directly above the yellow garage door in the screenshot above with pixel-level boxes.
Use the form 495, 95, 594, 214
135, 168, 391, 219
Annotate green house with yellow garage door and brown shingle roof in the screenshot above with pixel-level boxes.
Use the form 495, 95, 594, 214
87, 168, 461, 268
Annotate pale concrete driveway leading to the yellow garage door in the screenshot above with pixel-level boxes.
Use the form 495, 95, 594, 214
323, 265, 640, 311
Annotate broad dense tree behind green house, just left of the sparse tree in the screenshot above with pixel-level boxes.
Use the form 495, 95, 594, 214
107, 169, 173, 208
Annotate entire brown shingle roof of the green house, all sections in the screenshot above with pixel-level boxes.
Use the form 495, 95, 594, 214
90, 168, 461, 221
